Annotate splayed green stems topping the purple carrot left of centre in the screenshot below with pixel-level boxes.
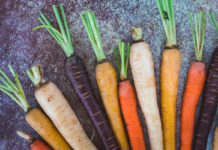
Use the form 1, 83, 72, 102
33, 4, 74, 57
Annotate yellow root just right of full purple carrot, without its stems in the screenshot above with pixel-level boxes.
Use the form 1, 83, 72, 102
96, 62, 129, 150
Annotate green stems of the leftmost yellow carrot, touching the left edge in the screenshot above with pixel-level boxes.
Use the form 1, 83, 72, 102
0, 65, 30, 112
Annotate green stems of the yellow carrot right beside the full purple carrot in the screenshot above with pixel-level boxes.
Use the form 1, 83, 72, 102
81, 10, 106, 62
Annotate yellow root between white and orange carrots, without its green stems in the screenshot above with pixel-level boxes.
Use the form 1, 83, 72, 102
160, 49, 181, 150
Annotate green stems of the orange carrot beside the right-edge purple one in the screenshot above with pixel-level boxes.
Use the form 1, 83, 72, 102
188, 11, 206, 61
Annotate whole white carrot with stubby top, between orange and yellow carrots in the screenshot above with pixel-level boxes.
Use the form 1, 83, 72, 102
130, 27, 163, 150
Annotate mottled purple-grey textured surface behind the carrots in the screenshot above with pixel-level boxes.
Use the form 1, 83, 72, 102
0, 0, 218, 150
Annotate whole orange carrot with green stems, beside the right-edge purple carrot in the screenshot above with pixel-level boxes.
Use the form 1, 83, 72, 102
180, 11, 207, 150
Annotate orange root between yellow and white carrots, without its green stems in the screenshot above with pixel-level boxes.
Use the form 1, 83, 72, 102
119, 80, 146, 150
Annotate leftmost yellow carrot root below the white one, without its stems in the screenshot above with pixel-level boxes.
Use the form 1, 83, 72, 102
25, 108, 71, 150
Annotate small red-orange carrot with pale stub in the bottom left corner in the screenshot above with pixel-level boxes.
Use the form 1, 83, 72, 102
16, 131, 51, 150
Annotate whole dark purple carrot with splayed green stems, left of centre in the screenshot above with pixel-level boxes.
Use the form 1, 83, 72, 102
34, 5, 119, 150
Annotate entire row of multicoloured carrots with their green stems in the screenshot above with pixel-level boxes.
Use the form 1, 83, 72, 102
0, 0, 218, 150
